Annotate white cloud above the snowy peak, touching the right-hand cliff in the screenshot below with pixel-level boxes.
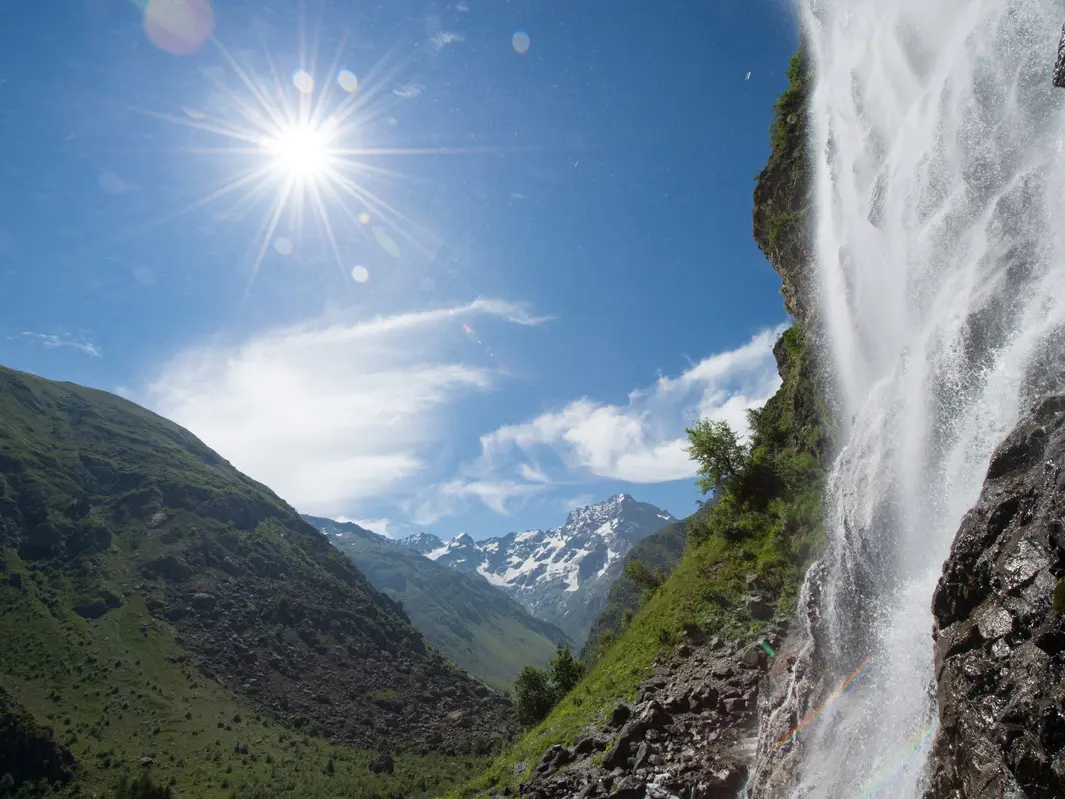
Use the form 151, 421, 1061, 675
423, 325, 786, 515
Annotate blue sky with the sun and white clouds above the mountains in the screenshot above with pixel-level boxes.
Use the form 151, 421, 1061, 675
0, 0, 797, 537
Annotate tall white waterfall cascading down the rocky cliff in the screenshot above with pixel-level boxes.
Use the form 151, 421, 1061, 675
790, 0, 1065, 799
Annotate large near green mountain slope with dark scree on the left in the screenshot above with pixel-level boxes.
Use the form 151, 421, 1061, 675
0, 368, 513, 797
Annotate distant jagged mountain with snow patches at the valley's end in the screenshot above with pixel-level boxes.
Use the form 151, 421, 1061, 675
398, 494, 676, 645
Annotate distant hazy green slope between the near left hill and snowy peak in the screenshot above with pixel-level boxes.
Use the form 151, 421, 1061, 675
304, 516, 572, 690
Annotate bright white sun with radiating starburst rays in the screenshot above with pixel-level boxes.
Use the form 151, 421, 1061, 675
144, 12, 495, 291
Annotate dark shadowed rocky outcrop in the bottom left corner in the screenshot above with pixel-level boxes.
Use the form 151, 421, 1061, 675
0, 688, 75, 796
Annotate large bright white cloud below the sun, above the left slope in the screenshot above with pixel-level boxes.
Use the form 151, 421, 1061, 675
145, 299, 543, 516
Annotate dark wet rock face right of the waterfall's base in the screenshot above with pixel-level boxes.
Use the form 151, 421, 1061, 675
925, 395, 1065, 799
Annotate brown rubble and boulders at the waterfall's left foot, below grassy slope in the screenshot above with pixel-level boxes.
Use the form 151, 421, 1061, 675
494, 630, 783, 799
